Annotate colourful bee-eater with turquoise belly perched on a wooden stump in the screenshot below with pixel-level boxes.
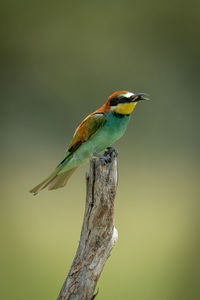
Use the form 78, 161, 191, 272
30, 91, 149, 195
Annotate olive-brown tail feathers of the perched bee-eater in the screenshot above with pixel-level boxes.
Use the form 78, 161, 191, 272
30, 166, 77, 195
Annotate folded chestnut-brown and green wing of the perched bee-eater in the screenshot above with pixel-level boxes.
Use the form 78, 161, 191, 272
67, 112, 106, 153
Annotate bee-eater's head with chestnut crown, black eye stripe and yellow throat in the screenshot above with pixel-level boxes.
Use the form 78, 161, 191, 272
107, 91, 149, 115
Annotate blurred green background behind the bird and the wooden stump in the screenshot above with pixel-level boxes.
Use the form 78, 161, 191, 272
0, 0, 200, 300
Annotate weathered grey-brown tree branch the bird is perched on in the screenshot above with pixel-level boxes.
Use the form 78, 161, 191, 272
57, 150, 118, 300
